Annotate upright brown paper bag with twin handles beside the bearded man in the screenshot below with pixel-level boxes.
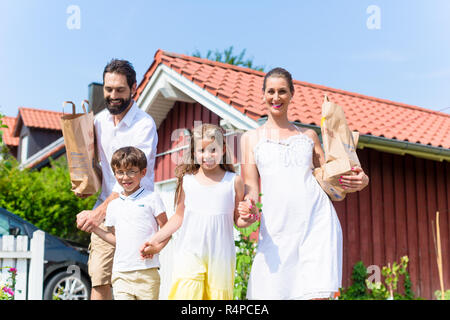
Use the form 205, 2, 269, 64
61, 100, 102, 196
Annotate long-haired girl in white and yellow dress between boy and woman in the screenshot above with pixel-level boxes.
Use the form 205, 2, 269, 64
141, 124, 257, 300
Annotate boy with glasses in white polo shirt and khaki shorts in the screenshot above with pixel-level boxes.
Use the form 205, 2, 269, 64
93, 147, 169, 300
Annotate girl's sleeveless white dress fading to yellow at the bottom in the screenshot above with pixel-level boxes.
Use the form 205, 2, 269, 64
169, 171, 236, 300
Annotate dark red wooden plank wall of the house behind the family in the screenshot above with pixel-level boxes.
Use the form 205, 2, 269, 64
155, 102, 450, 299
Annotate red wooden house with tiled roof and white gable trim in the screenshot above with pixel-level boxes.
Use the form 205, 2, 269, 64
134, 50, 450, 299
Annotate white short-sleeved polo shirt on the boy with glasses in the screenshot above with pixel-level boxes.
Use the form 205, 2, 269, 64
105, 187, 166, 272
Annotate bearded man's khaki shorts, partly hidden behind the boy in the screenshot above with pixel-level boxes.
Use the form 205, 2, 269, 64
88, 223, 115, 287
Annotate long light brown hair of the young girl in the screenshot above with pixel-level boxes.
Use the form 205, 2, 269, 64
174, 123, 235, 207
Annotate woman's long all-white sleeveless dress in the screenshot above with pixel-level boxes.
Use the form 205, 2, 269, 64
247, 133, 342, 300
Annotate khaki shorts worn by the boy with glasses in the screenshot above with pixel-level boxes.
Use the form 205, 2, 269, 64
112, 268, 161, 300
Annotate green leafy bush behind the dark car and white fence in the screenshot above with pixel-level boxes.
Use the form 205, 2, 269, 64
0, 157, 96, 244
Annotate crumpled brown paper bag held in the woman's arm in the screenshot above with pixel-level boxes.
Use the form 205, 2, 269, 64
313, 95, 361, 201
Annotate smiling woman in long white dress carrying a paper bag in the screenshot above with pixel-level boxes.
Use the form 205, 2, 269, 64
241, 68, 369, 299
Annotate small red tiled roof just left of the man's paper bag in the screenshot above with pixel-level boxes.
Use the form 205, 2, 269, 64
14, 107, 63, 136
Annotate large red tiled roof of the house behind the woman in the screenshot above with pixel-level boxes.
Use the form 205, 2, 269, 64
134, 50, 450, 148
